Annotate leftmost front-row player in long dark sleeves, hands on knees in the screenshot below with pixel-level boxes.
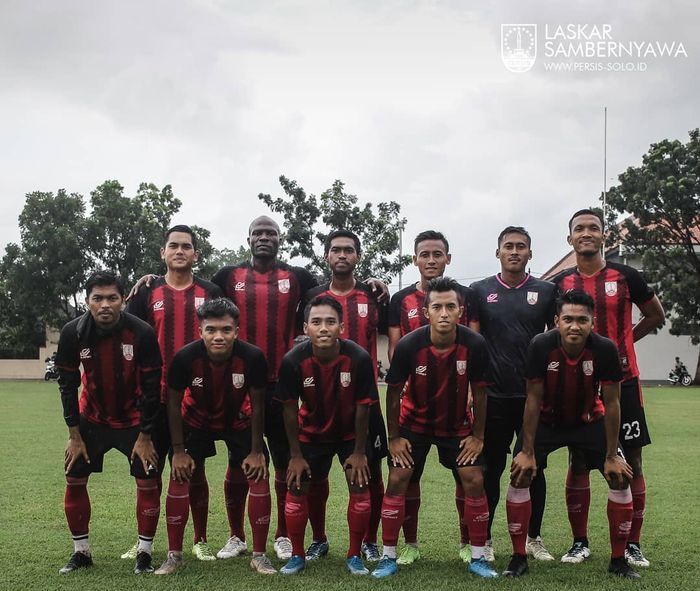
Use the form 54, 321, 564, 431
56, 271, 161, 573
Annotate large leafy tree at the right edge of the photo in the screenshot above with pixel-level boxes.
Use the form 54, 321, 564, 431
608, 129, 700, 383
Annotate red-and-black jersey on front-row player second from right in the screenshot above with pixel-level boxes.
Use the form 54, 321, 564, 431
386, 325, 489, 437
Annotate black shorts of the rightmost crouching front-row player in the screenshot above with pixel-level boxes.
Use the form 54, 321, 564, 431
513, 419, 620, 470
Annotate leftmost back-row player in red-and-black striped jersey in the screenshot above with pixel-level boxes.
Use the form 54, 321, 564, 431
122, 225, 223, 560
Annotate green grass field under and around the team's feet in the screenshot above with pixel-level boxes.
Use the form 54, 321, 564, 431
0, 382, 700, 591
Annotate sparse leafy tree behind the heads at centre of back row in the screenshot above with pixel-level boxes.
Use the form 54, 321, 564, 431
258, 176, 411, 283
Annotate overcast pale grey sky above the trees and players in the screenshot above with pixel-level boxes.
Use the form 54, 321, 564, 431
0, 0, 700, 290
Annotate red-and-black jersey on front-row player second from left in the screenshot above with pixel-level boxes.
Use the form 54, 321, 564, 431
168, 339, 267, 431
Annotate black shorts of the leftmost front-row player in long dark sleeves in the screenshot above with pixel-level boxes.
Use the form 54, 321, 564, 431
66, 416, 158, 478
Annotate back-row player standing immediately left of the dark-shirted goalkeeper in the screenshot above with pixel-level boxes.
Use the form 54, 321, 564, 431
389, 230, 479, 564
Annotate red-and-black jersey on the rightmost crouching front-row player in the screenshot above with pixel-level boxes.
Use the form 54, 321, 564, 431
525, 329, 622, 427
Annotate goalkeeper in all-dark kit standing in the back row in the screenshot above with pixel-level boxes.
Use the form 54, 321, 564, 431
471, 226, 556, 562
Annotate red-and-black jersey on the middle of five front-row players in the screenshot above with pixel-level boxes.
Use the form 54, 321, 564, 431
275, 339, 378, 443
